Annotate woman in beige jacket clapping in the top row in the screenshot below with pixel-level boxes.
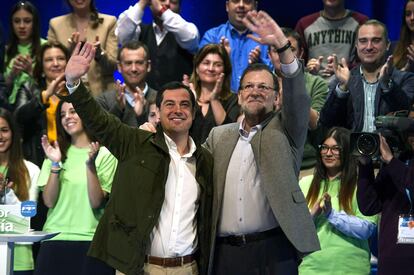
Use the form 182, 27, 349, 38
47, 0, 118, 96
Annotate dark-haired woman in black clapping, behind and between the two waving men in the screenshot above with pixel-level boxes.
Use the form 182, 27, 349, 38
190, 44, 240, 143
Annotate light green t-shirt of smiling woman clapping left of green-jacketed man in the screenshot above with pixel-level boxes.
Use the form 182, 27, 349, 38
37, 146, 117, 241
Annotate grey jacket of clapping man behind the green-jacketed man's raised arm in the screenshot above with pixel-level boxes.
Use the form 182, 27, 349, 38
96, 87, 157, 127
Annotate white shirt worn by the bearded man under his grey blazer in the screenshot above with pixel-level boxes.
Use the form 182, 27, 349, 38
219, 120, 278, 236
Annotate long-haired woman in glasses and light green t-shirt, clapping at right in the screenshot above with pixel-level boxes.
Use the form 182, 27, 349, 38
298, 127, 377, 274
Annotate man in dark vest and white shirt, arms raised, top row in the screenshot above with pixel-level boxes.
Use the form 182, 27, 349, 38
115, 0, 200, 90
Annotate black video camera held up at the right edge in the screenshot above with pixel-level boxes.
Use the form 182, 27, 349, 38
350, 112, 414, 159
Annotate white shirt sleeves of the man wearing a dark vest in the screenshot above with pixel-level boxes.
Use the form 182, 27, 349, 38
115, 3, 200, 53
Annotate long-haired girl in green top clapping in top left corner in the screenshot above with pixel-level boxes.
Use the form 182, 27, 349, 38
1, 0, 45, 111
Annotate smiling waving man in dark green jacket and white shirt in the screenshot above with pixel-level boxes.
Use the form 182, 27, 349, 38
60, 43, 212, 275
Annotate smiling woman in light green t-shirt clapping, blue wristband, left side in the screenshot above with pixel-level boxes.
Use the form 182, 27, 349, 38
35, 101, 117, 275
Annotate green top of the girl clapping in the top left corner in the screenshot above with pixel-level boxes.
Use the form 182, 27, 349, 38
4, 38, 46, 104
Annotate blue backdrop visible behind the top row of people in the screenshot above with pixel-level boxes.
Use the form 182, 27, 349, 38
0, 0, 405, 43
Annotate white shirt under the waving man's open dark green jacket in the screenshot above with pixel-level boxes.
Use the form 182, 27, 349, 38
147, 133, 200, 258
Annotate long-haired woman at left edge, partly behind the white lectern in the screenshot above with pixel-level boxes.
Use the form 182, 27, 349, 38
0, 108, 39, 275
